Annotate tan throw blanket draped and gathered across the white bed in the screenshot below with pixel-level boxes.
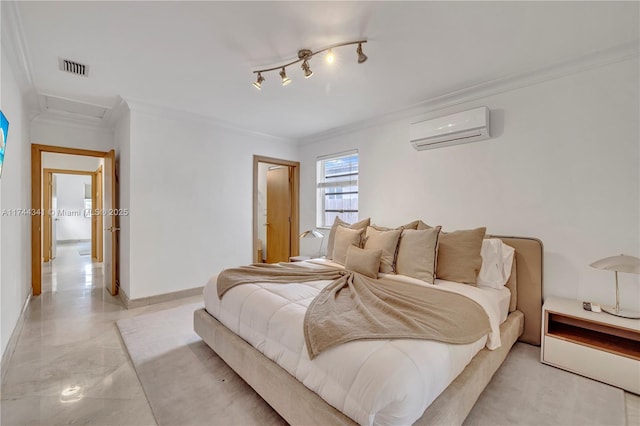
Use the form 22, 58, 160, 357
218, 264, 491, 359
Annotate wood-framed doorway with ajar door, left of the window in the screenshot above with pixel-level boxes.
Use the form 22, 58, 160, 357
252, 155, 300, 263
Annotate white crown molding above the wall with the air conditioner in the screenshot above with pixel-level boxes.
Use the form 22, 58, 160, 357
299, 40, 640, 145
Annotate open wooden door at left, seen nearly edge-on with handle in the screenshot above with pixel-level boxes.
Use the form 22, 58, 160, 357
102, 150, 120, 296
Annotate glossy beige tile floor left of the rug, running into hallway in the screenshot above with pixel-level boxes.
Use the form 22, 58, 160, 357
0, 244, 201, 425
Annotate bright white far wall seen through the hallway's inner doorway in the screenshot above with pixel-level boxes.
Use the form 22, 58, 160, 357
55, 174, 91, 241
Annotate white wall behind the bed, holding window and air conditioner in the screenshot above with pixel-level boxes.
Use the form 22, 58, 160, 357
301, 58, 640, 310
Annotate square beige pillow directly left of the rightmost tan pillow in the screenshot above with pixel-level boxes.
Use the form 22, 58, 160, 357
396, 226, 440, 284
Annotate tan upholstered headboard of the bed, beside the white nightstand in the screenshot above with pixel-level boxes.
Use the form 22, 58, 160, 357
491, 235, 543, 345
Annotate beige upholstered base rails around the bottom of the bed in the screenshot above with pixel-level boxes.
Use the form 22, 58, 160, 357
193, 309, 524, 425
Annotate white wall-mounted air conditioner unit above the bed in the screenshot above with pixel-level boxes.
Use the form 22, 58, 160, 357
409, 107, 491, 151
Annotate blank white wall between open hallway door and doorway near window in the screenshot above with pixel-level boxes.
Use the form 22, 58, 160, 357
125, 105, 298, 299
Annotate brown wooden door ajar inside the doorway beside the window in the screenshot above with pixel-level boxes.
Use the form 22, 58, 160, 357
265, 166, 291, 263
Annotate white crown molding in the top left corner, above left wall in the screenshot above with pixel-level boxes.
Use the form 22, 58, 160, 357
0, 0, 36, 93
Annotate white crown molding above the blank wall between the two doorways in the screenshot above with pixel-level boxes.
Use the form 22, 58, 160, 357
123, 97, 299, 144
